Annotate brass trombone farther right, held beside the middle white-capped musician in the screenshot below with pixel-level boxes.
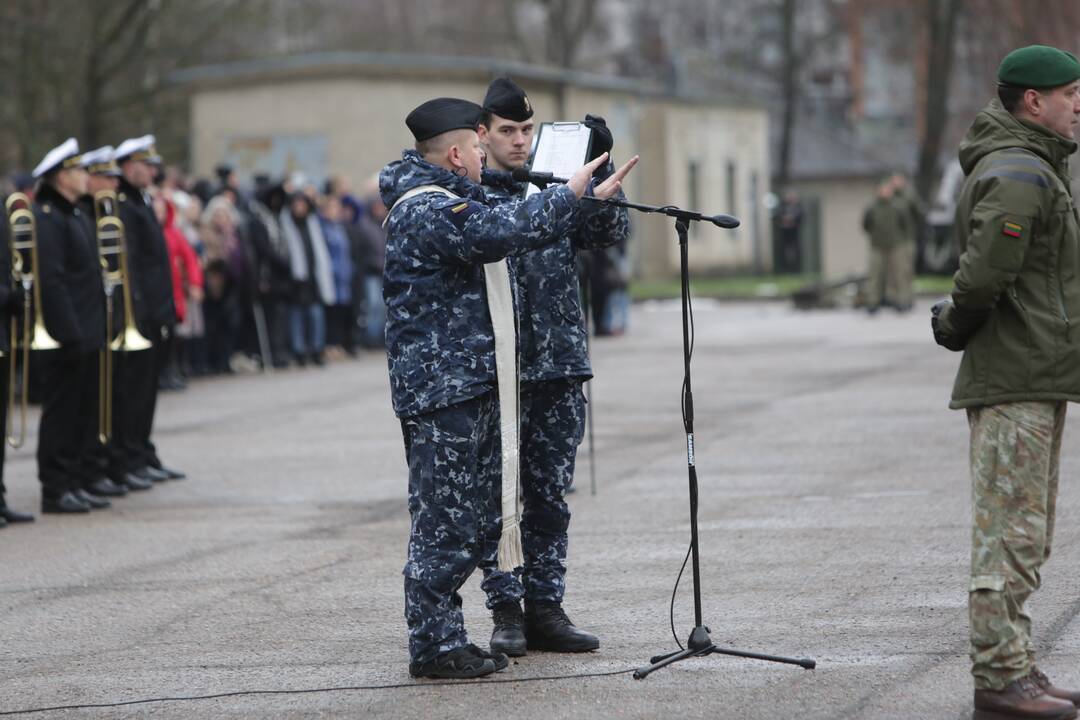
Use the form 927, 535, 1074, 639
94, 190, 151, 445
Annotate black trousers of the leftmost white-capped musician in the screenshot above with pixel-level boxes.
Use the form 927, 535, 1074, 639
38, 348, 97, 498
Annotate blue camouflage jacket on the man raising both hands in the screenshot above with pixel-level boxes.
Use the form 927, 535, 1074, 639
379, 150, 578, 418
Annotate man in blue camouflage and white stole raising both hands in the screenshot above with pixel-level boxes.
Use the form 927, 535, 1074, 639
379, 98, 633, 678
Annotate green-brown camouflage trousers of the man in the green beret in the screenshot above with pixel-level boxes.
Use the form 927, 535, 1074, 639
968, 403, 1065, 690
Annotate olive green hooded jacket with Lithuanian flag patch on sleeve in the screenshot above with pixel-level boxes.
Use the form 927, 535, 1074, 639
939, 100, 1080, 408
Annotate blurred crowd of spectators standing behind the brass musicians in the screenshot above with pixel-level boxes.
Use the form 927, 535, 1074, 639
78, 165, 387, 390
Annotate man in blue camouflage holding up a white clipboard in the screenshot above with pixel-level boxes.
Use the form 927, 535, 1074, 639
480, 78, 630, 656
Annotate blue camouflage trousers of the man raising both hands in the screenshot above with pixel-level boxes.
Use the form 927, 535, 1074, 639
402, 392, 501, 663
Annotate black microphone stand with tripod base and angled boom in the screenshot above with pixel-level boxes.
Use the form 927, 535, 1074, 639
570, 188, 816, 680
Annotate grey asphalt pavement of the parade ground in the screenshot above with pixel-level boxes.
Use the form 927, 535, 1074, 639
0, 301, 1080, 720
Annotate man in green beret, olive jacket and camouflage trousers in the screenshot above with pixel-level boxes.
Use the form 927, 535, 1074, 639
932, 45, 1080, 718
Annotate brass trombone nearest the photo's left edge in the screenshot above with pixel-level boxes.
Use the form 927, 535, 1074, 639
4, 192, 60, 448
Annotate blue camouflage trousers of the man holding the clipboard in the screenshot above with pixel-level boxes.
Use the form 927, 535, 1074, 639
481, 378, 585, 609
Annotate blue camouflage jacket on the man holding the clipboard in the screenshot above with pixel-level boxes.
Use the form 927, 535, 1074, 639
484, 163, 630, 382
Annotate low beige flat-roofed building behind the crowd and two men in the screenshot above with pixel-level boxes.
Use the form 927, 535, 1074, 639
171, 53, 772, 277
